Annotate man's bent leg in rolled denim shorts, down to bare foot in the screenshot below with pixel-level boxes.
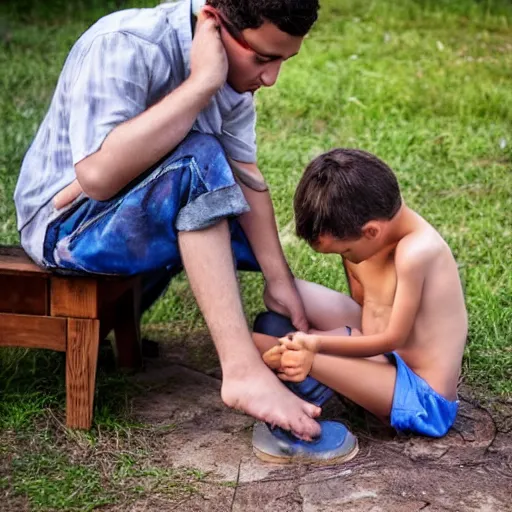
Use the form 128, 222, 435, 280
45, 134, 319, 438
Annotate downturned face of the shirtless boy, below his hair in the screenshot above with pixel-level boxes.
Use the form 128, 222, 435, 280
312, 231, 381, 264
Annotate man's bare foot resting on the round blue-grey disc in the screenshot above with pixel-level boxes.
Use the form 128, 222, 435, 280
221, 365, 321, 441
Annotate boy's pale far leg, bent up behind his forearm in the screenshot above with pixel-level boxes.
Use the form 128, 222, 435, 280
295, 279, 361, 331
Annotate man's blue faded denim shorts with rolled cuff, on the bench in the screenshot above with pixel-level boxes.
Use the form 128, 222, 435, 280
43, 132, 259, 309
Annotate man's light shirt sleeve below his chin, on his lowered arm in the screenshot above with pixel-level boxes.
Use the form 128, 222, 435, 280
220, 94, 256, 163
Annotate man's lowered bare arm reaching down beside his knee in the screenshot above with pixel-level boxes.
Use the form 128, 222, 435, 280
234, 162, 308, 330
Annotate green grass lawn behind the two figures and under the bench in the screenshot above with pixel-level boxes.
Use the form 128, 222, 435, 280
0, 0, 512, 510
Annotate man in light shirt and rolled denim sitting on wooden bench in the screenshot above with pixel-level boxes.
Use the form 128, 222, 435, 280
15, 0, 319, 439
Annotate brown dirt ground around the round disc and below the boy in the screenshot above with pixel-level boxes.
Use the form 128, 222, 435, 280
107, 336, 512, 512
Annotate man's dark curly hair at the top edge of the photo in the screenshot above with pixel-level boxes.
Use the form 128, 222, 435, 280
206, 0, 319, 36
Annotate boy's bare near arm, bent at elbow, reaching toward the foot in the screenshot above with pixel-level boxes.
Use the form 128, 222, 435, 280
290, 244, 430, 357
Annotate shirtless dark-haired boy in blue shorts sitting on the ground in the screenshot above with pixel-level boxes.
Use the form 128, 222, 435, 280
254, 149, 467, 437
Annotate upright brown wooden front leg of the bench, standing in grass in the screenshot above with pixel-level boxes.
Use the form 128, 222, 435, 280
66, 318, 100, 429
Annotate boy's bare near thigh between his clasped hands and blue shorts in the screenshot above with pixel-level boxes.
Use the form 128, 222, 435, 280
310, 354, 396, 418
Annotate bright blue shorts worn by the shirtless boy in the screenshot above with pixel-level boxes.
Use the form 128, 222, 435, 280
386, 352, 459, 437
